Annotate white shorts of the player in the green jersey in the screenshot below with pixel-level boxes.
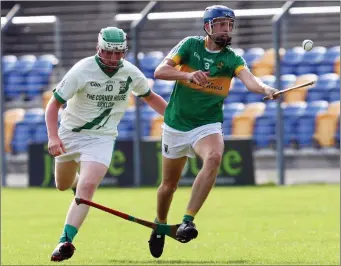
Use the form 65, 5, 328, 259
162, 123, 223, 159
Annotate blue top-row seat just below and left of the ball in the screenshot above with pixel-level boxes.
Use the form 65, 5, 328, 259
281, 47, 305, 75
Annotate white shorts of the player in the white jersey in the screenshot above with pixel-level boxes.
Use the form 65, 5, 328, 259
55, 126, 115, 168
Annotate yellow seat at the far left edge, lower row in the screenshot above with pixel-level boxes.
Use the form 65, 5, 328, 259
4, 108, 25, 152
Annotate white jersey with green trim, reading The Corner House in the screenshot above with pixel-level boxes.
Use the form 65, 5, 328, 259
54, 56, 150, 137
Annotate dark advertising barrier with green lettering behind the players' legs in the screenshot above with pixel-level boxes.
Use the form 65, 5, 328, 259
28, 139, 255, 187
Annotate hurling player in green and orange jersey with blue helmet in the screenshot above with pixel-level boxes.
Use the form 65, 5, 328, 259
149, 5, 277, 258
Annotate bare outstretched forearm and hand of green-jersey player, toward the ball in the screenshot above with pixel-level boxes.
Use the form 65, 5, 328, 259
238, 69, 278, 100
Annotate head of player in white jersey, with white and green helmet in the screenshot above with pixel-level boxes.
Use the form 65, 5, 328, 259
97, 27, 128, 68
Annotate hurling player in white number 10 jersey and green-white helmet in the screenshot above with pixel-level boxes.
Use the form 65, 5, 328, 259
46, 27, 167, 261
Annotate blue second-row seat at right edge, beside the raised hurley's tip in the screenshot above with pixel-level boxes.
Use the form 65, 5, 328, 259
306, 73, 340, 102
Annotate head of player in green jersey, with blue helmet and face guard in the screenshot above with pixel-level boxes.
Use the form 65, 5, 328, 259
204, 5, 236, 47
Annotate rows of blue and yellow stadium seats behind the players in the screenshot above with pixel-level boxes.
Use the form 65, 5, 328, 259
2, 46, 340, 153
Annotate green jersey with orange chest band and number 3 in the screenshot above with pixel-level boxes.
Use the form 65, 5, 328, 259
164, 36, 247, 131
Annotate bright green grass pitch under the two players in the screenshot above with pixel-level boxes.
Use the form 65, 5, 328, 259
1, 185, 340, 265
